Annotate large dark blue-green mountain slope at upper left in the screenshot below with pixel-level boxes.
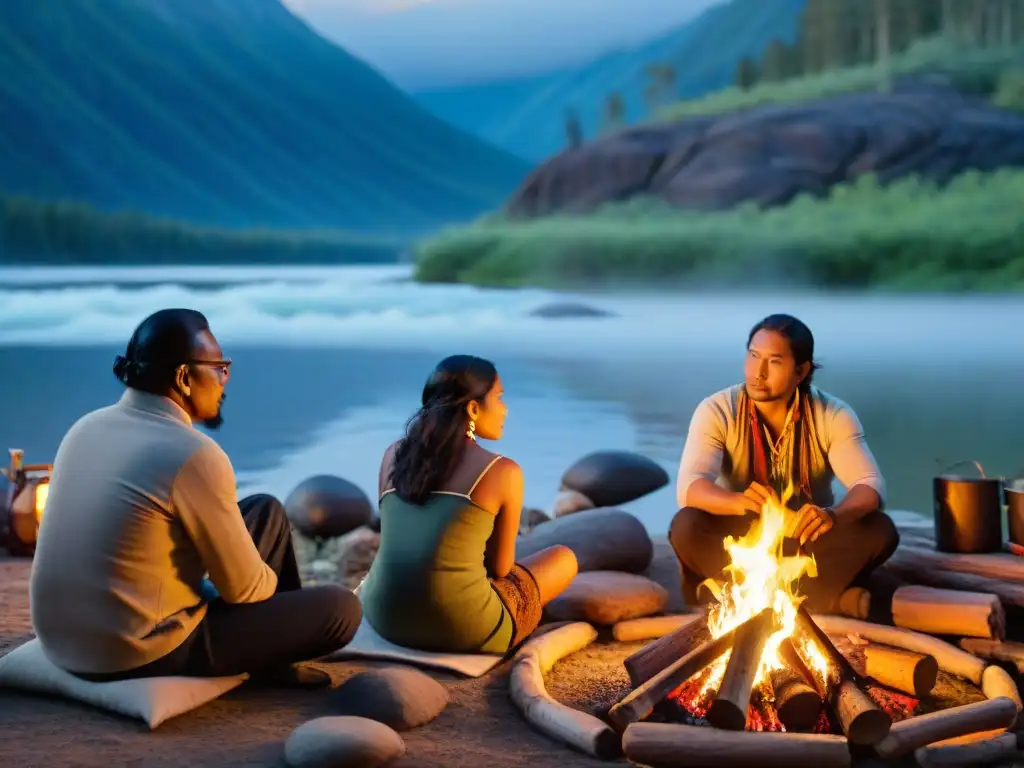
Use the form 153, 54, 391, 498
0, 0, 528, 231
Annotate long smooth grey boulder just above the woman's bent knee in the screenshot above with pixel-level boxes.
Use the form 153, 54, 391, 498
515, 509, 654, 573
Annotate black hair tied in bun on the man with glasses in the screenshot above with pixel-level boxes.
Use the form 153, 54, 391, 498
114, 309, 210, 394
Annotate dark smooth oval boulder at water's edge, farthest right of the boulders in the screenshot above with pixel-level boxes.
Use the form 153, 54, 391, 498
562, 451, 669, 507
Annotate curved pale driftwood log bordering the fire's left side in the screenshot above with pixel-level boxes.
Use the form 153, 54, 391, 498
509, 622, 622, 760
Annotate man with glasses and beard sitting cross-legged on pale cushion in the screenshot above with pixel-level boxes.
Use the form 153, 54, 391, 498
31, 309, 361, 686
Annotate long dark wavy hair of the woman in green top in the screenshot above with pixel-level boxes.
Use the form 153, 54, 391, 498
390, 354, 498, 512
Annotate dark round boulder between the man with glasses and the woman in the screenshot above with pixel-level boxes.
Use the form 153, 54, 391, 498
285, 475, 374, 539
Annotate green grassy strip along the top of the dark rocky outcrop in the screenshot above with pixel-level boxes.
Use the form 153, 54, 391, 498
654, 38, 1024, 122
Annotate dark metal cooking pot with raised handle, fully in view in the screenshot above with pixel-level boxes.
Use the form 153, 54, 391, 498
932, 462, 1003, 554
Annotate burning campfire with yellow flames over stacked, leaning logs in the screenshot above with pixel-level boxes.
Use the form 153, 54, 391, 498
608, 490, 892, 744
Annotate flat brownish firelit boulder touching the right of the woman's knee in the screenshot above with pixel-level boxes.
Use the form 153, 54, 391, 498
545, 570, 669, 626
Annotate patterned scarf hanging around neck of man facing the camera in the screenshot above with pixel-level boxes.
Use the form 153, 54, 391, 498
736, 387, 818, 503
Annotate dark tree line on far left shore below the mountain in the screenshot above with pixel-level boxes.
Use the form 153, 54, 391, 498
0, 196, 401, 265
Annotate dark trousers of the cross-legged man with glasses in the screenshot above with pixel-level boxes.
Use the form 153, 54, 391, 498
79, 495, 362, 681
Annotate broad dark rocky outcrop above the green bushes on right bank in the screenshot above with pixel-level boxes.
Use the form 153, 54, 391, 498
507, 79, 1024, 218
